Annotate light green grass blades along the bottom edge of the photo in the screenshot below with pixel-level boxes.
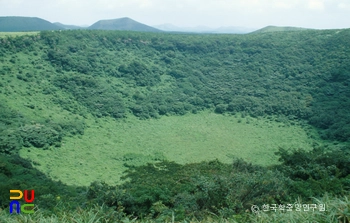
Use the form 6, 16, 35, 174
0, 195, 350, 223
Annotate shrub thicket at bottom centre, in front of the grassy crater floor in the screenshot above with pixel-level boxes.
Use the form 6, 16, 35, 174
88, 160, 287, 220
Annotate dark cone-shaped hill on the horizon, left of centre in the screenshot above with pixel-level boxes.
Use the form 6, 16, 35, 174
88, 17, 161, 32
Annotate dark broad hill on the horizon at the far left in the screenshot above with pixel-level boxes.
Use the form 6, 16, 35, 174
0, 16, 62, 32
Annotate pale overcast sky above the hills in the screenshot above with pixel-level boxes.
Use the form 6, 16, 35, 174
0, 0, 350, 29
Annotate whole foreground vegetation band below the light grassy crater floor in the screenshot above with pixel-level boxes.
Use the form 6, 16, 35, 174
0, 152, 350, 222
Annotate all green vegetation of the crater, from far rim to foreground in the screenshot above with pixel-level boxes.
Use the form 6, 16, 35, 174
0, 30, 350, 222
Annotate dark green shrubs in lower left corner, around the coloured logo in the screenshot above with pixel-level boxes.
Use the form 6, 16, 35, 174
0, 154, 85, 211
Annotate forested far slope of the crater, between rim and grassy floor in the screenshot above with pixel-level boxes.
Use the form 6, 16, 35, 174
0, 30, 350, 146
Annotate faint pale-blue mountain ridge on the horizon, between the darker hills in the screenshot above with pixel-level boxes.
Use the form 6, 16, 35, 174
154, 23, 255, 34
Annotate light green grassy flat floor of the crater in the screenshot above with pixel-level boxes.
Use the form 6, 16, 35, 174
20, 112, 320, 185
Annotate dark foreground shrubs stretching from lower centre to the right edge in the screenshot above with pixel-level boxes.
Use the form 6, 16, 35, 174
87, 148, 350, 221
